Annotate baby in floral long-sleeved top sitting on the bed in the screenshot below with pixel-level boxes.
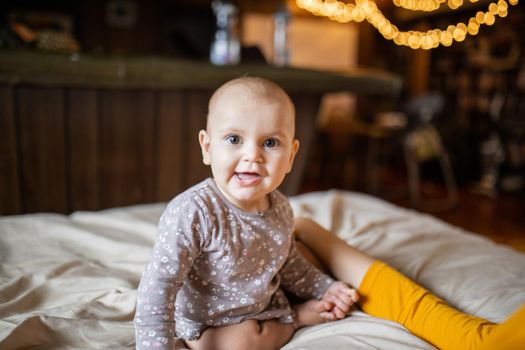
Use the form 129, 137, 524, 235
135, 77, 358, 350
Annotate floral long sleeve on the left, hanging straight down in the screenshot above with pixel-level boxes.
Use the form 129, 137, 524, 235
135, 202, 202, 349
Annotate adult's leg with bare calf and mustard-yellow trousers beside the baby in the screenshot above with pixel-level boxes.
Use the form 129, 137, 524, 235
295, 219, 495, 349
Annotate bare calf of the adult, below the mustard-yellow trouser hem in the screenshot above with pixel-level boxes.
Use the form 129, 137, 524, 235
295, 218, 375, 288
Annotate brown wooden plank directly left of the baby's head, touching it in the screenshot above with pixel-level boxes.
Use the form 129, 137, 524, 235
183, 90, 211, 186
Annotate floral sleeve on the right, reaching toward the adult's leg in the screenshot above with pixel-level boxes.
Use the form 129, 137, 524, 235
280, 241, 334, 299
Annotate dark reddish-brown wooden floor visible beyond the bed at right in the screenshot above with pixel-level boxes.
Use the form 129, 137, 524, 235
302, 131, 525, 251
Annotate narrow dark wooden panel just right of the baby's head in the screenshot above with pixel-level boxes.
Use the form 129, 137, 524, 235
279, 94, 321, 195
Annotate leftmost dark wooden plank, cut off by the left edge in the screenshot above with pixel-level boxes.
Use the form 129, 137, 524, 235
0, 86, 22, 215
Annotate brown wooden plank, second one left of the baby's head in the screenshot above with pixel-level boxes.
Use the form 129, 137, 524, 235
155, 92, 185, 201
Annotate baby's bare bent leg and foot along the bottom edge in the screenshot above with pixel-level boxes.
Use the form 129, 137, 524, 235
186, 300, 332, 350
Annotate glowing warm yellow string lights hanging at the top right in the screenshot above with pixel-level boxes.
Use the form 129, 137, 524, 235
296, 0, 518, 50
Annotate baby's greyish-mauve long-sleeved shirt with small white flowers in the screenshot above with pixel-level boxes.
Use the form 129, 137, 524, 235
135, 178, 333, 349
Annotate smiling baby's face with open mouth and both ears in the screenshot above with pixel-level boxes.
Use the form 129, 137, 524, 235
199, 85, 299, 211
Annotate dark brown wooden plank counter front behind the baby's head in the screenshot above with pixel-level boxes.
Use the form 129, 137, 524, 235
0, 84, 320, 215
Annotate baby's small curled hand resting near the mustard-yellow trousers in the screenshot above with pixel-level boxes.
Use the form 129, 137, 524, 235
322, 281, 359, 320
